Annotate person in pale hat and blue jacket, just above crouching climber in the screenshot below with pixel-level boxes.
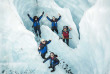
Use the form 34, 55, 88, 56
38, 39, 51, 59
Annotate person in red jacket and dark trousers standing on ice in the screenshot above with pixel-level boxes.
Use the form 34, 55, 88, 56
62, 26, 72, 46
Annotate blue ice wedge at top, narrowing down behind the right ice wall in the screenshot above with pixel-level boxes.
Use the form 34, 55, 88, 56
54, 0, 96, 36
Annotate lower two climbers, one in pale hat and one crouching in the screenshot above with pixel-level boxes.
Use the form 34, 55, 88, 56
38, 39, 59, 72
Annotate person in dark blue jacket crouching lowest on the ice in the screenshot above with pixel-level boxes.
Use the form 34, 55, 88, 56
43, 52, 59, 72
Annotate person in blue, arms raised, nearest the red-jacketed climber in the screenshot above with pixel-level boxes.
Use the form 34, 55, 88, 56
46, 14, 61, 34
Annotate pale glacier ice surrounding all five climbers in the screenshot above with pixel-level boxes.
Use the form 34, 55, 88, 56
0, 0, 110, 74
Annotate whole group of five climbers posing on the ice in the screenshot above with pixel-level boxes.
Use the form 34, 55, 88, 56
27, 12, 72, 72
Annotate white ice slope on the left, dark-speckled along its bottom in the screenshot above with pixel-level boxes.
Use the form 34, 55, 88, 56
0, 0, 64, 74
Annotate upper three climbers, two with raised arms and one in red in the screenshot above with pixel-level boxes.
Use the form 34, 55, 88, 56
27, 12, 72, 46
